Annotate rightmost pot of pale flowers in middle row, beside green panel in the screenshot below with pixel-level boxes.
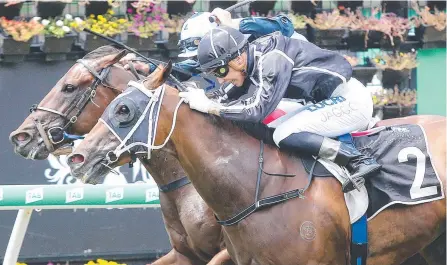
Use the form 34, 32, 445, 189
373, 52, 417, 88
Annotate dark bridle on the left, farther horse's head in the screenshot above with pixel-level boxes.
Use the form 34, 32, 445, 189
30, 59, 121, 153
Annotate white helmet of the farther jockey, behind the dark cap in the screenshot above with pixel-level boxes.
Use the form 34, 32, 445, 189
178, 12, 217, 57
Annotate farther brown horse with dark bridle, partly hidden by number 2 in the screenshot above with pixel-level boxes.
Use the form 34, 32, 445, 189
10, 46, 233, 265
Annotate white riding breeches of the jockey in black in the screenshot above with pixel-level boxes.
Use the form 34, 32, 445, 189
273, 78, 373, 145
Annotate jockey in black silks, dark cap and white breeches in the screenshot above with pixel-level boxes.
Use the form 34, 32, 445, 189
180, 26, 381, 192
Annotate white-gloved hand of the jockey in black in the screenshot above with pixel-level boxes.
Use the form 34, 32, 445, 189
179, 89, 219, 115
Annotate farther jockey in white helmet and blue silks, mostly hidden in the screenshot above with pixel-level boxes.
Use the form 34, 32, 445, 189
121, 8, 307, 85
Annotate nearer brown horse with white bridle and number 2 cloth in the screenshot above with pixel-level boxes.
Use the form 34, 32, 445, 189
68, 62, 446, 265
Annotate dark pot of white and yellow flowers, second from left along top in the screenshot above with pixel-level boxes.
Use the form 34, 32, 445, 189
38, 14, 83, 61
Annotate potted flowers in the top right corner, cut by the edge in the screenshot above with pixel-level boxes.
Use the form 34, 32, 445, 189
413, 4, 446, 48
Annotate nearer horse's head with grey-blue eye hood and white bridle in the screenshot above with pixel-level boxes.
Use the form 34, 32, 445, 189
67, 62, 172, 183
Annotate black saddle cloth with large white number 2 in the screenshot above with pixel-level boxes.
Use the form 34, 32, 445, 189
351, 125, 444, 220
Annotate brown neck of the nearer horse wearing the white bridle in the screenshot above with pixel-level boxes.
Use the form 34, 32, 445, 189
166, 103, 296, 219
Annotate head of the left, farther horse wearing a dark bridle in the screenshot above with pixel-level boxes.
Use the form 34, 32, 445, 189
10, 46, 136, 159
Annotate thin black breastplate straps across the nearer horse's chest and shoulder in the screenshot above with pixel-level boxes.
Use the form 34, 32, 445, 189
214, 141, 317, 226
